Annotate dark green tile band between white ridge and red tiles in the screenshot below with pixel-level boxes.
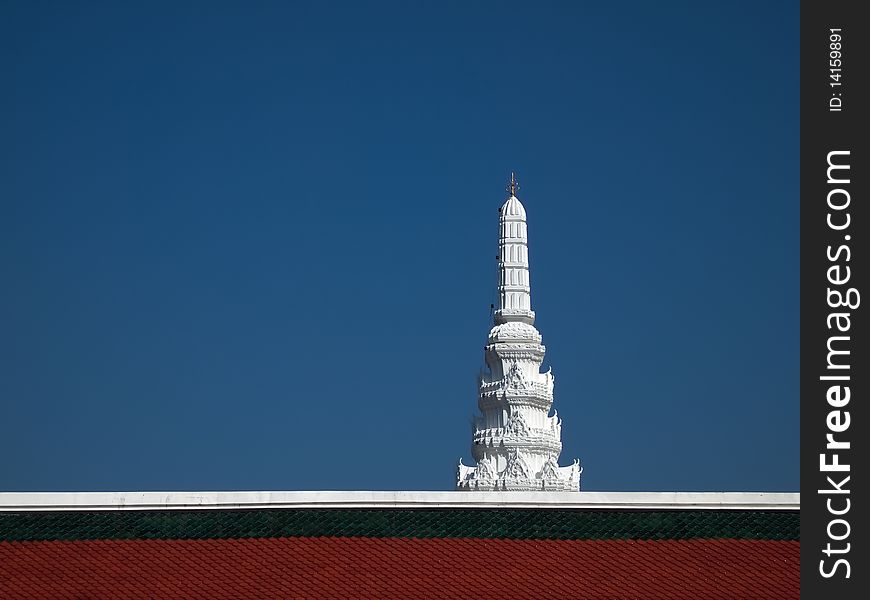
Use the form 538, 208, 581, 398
0, 508, 800, 541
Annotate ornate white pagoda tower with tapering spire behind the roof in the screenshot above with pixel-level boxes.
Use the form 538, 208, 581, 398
456, 173, 583, 491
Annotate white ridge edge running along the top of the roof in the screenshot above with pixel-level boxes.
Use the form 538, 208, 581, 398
0, 491, 800, 512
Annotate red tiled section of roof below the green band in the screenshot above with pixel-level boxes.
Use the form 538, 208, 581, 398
0, 537, 800, 599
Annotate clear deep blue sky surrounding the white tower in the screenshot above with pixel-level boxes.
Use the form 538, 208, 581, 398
0, 1, 799, 490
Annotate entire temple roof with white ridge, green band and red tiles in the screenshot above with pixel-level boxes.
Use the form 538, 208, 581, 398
0, 492, 800, 599
